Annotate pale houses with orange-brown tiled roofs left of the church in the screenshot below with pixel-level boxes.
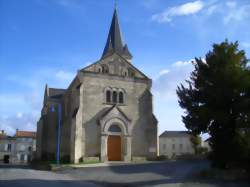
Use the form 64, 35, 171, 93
0, 129, 36, 164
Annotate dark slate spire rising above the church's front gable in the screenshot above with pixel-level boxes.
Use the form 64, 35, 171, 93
102, 4, 132, 60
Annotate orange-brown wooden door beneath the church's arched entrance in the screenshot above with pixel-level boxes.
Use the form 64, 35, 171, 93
108, 135, 121, 161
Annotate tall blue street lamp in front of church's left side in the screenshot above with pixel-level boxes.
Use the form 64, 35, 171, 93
51, 103, 62, 165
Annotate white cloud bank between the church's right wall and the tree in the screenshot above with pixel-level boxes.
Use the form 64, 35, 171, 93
152, 60, 193, 133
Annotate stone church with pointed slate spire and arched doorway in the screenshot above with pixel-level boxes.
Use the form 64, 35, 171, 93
37, 8, 158, 163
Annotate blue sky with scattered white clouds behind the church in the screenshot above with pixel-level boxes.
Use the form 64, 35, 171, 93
0, 0, 250, 134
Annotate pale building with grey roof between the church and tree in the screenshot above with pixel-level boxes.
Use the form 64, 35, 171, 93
159, 131, 194, 158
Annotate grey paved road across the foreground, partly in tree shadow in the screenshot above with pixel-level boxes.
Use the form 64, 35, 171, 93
0, 161, 249, 187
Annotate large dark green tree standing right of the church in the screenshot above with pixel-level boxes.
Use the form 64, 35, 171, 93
177, 40, 250, 167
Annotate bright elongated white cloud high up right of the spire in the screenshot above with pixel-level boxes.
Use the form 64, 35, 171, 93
152, 0, 204, 23
